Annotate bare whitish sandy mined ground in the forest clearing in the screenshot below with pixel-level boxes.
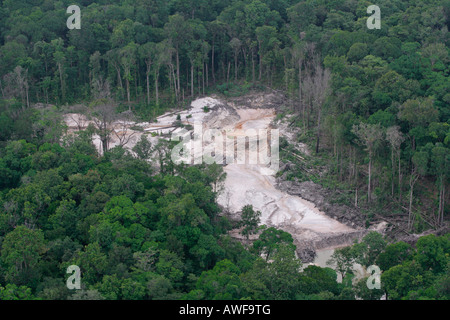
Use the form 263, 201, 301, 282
65, 93, 367, 264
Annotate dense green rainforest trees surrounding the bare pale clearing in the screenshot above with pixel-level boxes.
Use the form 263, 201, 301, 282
0, 0, 450, 300
